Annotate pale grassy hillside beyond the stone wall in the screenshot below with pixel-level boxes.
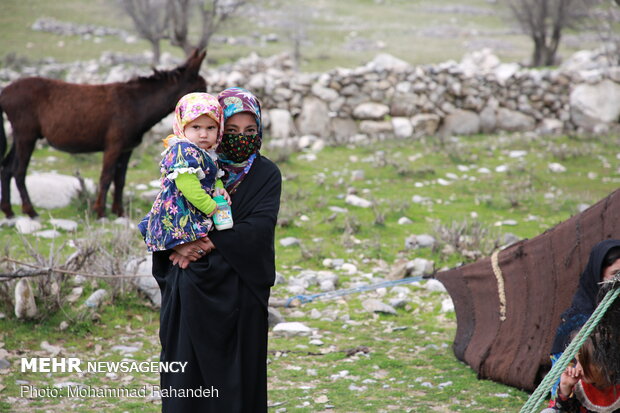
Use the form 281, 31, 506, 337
0, 0, 596, 71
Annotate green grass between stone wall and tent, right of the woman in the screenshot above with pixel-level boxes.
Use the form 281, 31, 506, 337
270, 136, 617, 270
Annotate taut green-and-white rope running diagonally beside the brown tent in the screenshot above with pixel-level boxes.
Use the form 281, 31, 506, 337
520, 274, 620, 413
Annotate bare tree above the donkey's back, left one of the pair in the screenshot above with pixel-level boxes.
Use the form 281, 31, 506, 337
119, 0, 170, 65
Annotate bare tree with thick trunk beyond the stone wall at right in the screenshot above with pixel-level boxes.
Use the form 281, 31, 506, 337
508, 0, 596, 66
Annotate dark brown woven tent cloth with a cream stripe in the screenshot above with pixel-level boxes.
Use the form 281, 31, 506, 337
435, 190, 620, 390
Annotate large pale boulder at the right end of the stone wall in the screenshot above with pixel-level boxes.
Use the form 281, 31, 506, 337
570, 79, 620, 130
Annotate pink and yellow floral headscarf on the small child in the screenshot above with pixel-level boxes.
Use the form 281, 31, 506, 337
164, 92, 224, 147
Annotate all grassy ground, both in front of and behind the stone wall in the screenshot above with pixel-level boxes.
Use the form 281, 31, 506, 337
0, 0, 620, 413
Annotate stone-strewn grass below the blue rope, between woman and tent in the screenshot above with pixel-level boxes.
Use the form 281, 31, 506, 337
270, 284, 526, 412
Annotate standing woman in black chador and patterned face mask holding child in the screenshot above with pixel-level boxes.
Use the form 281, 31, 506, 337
153, 88, 282, 413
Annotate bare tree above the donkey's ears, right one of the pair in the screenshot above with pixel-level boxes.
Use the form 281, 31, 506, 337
169, 0, 250, 55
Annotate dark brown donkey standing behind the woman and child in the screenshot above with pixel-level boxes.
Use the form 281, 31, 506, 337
0, 50, 206, 218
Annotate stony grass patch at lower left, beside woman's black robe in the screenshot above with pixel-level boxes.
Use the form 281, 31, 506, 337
0, 290, 159, 412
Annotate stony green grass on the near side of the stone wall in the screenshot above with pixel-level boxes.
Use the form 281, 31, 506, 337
0, 131, 620, 412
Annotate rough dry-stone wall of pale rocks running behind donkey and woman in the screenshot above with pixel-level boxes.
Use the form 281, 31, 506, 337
0, 50, 620, 142
